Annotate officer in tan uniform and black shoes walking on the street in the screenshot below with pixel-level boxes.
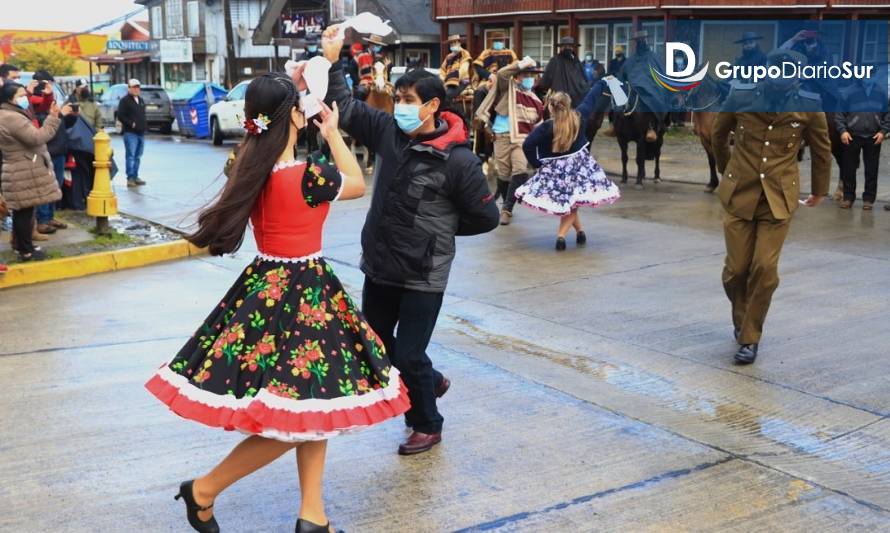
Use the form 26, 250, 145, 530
713, 51, 831, 364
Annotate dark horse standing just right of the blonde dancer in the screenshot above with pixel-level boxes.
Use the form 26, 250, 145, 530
615, 83, 669, 190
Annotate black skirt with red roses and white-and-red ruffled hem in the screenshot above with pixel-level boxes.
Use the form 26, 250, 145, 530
145, 254, 410, 442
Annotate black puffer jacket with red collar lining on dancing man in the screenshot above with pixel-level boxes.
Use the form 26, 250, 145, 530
326, 62, 498, 292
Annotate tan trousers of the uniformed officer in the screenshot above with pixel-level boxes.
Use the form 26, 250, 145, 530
723, 198, 791, 344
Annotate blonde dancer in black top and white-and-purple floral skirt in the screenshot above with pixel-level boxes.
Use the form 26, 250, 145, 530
516, 84, 621, 251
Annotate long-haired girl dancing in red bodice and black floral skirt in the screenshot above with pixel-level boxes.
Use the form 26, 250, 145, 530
146, 74, 410, 533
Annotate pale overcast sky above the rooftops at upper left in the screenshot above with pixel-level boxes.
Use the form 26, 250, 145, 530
0, 0, 148, 33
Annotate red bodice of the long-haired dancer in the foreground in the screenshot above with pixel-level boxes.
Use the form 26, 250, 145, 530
250, 161, 331, 258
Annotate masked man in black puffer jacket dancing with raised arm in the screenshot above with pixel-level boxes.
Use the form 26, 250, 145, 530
322, 26, 498, 455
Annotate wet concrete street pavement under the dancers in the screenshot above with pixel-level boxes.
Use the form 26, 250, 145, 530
0, 137, 890, 532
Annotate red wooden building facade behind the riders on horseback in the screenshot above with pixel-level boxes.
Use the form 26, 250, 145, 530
432, 0, 890, 67
